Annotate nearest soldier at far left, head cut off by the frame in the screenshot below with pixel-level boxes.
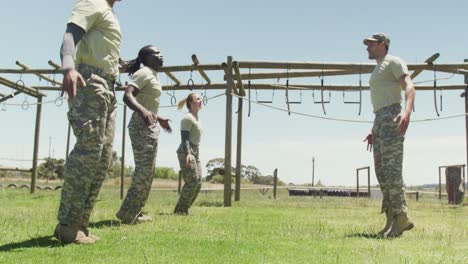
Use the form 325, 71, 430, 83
54, 0, 121, 244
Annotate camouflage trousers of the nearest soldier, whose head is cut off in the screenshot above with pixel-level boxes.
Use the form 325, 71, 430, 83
57, 65, 117, 227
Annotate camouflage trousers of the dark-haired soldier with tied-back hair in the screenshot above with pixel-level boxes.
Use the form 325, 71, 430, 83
120, 112, 159, 219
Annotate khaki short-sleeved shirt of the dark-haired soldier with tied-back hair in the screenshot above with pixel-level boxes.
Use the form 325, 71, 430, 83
129, 66, 162, 114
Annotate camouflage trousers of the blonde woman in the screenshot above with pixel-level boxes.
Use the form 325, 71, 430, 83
176, 144, 202, 210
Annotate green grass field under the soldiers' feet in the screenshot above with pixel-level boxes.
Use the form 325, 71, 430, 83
0, 186, 468, 263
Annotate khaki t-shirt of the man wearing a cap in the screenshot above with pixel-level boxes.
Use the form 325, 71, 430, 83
369, 54, 408, 112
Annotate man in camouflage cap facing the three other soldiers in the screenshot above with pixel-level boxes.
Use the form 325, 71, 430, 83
363, 33, 416, 237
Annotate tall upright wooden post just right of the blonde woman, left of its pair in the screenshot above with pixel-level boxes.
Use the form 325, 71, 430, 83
224, 56, 234, 207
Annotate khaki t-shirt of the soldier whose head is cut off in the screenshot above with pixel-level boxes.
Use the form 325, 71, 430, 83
68, 0, 122, 79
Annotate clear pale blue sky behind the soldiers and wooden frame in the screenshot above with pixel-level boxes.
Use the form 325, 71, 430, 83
0, 0, 468, 185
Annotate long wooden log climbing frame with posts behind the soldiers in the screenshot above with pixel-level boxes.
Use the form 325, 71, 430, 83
0, 54, 468, 206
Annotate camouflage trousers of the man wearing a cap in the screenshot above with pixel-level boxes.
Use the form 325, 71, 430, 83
372, 104, 408, 213
